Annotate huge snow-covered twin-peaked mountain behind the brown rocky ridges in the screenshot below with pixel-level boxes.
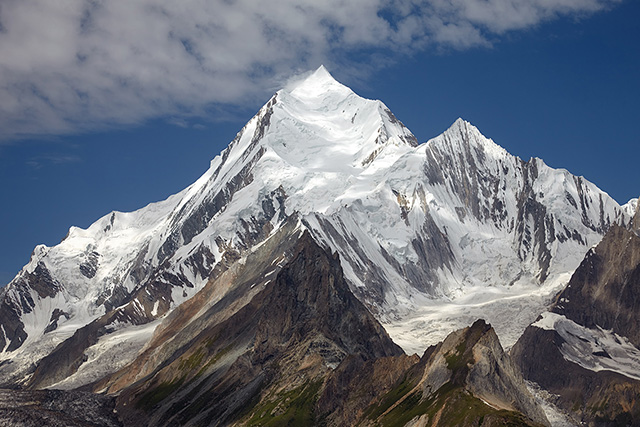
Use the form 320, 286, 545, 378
0, 67, 631, 388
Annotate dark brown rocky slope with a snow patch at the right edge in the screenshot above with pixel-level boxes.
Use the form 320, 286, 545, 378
511, 207, 640, 425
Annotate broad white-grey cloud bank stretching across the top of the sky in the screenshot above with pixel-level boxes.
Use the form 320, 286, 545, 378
0, 0, 618, 140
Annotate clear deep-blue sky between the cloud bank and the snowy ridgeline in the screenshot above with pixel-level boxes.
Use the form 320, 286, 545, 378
0, 1, 640, 294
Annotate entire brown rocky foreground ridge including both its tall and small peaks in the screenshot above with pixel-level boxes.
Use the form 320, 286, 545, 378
95, 230, 547, 426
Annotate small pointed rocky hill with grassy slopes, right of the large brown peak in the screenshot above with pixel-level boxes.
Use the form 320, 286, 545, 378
356, 320, 548, 426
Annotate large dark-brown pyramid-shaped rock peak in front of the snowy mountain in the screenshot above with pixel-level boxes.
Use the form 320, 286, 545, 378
107, 232, 402, 425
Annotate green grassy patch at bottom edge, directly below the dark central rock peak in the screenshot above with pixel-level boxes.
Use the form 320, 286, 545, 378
247, 381, 322, 427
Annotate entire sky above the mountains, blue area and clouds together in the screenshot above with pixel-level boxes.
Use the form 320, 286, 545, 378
0, 0, 640, 286
